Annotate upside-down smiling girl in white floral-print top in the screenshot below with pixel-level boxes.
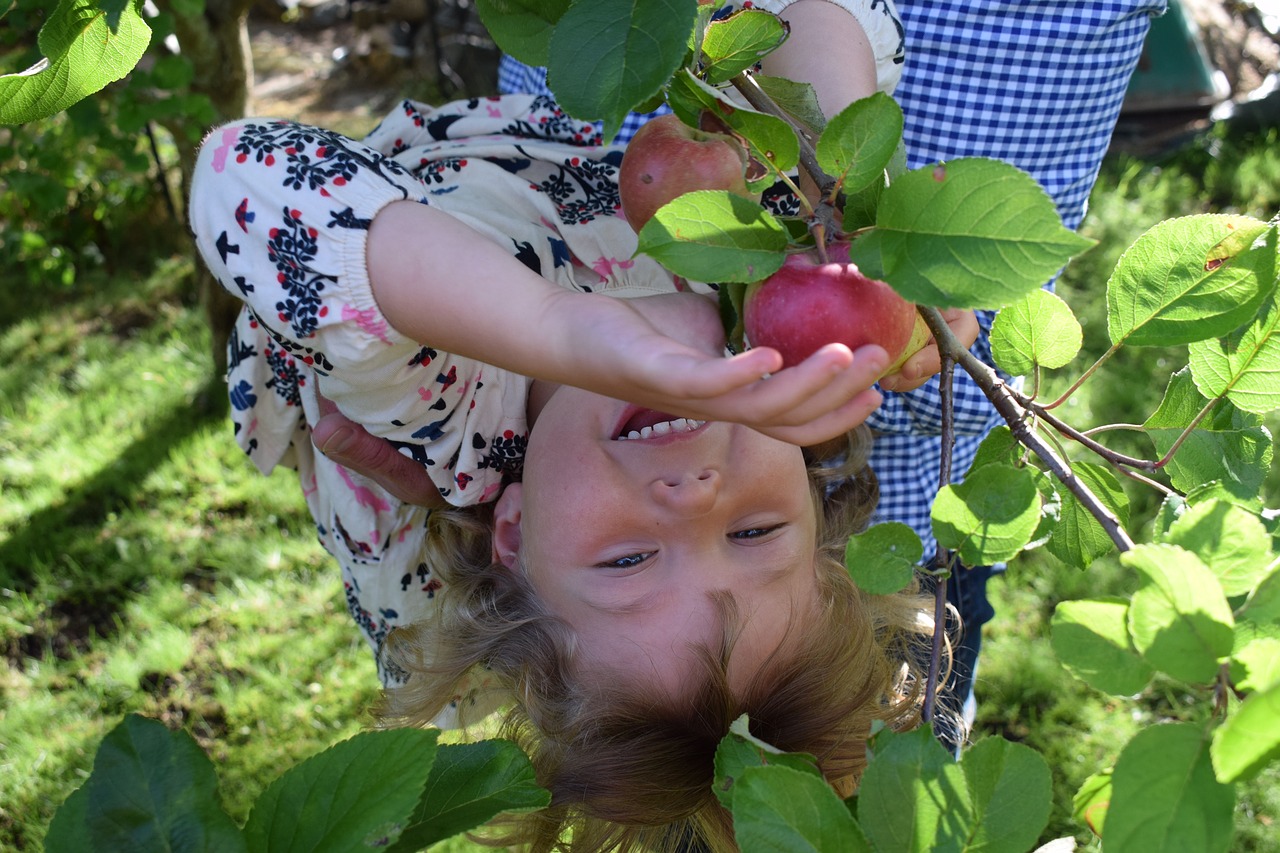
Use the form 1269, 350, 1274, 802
191, 0, 928, 849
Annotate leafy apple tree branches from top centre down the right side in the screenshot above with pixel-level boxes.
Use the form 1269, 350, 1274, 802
479, 0, 1280, 853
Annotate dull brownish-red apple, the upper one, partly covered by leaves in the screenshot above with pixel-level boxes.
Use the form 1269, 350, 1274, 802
618, 115, 754, 232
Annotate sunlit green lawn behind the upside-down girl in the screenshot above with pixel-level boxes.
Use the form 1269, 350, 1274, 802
0, 122, 1280, 852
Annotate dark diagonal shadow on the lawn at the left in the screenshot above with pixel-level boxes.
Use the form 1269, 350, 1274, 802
0, 379, 227, 658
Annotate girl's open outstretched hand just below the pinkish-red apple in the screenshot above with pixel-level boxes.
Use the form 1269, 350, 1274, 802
550, 291, 888, 446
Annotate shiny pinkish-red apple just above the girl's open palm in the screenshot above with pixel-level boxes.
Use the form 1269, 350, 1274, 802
742, 243, 929, 373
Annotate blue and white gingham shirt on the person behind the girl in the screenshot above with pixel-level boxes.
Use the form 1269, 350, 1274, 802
498, 0, 1166, 558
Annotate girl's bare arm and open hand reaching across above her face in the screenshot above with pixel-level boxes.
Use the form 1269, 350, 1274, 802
367, 201, 887, 444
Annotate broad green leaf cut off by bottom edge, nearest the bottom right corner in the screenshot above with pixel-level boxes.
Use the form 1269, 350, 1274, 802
1102, 722, 1235, 853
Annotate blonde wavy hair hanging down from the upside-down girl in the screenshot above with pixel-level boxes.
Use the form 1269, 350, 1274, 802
378, 429, 932, 852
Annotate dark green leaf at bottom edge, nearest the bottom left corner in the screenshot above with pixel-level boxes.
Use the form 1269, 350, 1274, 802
84, 713, 244, 853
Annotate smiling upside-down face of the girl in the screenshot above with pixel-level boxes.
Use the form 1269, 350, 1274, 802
494, 387, 817, 693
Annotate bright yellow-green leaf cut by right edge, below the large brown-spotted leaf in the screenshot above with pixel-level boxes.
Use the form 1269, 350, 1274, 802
1190, 281, 1280, 414
